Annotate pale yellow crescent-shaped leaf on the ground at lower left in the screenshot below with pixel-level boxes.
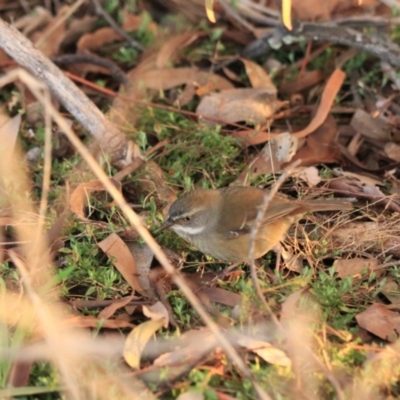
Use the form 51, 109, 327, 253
123, 319, 165, 369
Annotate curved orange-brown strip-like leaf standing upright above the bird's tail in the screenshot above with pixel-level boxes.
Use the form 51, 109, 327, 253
293, 68, 346, 138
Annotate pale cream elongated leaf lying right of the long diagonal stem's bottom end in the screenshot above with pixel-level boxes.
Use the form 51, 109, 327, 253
238, 335, 292, 367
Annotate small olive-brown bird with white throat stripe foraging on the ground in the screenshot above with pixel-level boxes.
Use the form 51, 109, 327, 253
158, 186, 353, 263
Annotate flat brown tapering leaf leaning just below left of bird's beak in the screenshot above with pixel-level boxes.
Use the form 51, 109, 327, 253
97, 233, 147, 296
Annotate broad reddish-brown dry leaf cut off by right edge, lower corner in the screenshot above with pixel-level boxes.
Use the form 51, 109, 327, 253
356, 304, 400, 342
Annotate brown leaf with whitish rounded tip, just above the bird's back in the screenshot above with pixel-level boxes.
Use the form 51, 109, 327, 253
235, 132, 298, 184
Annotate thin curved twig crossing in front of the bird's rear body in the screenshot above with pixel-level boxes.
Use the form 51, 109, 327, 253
249, 160, 301, 308
